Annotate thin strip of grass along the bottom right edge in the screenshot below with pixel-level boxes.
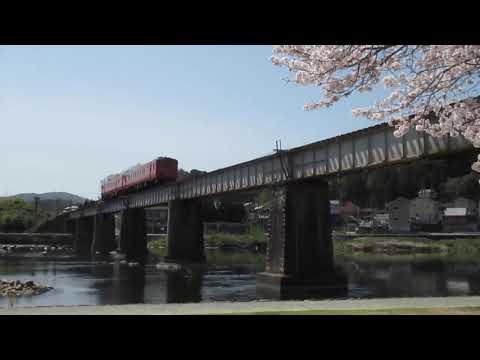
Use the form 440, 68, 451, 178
224, 307, 480, 315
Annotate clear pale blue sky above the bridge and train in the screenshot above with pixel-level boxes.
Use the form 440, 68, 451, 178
0, 45, 382, 198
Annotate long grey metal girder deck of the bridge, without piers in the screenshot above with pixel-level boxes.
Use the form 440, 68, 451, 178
70, 124, 473, 218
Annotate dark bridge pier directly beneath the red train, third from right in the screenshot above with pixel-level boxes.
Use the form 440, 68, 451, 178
120, 208, 147, 262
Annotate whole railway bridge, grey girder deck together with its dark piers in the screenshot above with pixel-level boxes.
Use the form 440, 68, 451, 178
63, 124, 472, 297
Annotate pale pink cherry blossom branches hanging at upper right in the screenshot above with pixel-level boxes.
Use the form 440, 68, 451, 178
271, 45, 480, 176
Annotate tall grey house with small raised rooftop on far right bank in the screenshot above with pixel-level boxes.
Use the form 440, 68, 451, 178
410, 189, 442, 231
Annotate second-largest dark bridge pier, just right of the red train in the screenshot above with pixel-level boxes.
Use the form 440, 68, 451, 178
166, 199, 205, 262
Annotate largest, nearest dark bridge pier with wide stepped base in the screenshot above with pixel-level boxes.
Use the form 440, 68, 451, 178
257, 180, 347, 299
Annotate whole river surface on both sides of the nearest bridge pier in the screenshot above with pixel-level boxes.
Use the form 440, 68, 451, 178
0, 242, 480, 307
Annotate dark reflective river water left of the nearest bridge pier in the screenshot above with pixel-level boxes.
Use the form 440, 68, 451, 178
0, 253, 263, 307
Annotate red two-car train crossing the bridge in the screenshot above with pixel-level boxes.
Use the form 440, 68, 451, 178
100, 157, 178, 199
